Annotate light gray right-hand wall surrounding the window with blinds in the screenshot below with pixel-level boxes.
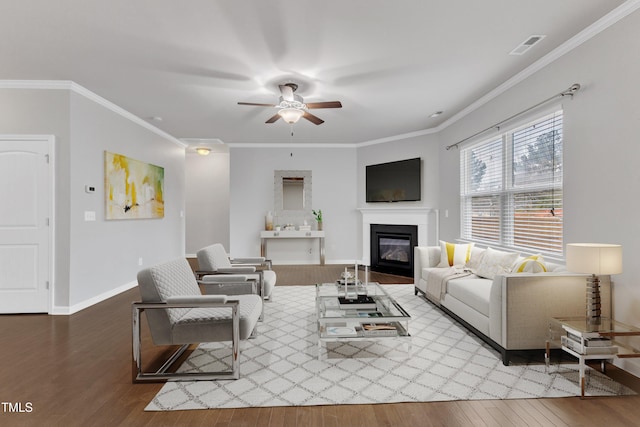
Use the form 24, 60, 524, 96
440, 11, 640, 375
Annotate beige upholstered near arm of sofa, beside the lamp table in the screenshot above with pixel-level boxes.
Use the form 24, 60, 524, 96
489, 273, 611, 350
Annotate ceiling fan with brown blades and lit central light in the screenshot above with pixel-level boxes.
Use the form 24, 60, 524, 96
238, 83, 342, 125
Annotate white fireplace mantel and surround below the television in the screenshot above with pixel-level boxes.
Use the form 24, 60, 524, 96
358, 207, 439, 265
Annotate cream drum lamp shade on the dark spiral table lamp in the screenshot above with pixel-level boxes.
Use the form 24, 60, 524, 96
566, 243, 622, 276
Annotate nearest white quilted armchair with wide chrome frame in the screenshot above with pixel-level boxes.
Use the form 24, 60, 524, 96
132, 258, 262, 382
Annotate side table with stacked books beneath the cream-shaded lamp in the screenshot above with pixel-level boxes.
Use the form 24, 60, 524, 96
545, 316, 640, 398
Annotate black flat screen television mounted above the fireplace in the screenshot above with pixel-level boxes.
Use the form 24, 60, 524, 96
366, 157, 422, 203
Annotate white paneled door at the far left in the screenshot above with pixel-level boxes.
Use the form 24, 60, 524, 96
0, 137, 53, 313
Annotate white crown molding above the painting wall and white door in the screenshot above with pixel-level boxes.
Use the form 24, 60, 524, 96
0, 80, 187, 148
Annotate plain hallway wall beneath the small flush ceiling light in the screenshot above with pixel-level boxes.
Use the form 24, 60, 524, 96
185, 145, 230, 255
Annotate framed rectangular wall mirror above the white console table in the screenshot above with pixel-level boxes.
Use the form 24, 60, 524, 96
273, 170, 312, 215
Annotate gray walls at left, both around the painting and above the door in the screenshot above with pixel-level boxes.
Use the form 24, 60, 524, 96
0, 88, 184, 313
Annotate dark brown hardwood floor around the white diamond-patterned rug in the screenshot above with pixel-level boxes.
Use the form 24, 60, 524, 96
0, 266, 640, 427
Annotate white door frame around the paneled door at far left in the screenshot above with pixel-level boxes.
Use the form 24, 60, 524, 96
0, 134, 56, 314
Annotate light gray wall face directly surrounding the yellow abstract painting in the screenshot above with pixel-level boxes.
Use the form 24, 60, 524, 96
69, 92, 185, 308
